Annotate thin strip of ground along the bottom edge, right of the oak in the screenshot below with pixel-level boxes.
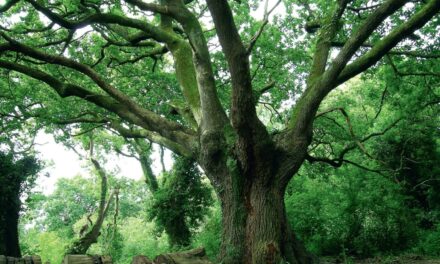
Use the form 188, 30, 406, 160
320, 255, 440, 264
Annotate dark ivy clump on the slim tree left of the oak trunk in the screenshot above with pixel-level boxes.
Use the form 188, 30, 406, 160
149, 157, 212, 247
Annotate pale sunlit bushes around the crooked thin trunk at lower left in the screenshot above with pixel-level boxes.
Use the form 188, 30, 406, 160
20, 173, 154, 263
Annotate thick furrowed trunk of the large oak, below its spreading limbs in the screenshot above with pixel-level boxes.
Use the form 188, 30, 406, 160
201, 152, 315, 264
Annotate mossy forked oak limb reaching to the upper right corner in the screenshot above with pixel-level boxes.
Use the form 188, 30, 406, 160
290, 0, 440, 154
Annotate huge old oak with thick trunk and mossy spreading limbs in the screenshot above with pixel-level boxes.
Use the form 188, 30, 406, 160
0, 0, 440, 263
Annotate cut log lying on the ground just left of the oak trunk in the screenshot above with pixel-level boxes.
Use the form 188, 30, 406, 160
153, 248, 212, 264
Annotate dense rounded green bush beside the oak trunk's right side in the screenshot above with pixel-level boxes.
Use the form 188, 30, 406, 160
286, 166, 416, 257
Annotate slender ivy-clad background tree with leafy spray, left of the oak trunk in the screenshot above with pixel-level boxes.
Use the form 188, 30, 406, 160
78, 129, 212, 249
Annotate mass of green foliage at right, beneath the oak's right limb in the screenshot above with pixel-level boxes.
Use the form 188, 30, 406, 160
286, 68, 440, 256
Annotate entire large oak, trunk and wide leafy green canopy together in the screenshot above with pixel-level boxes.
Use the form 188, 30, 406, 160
0, 0, 440, 263
